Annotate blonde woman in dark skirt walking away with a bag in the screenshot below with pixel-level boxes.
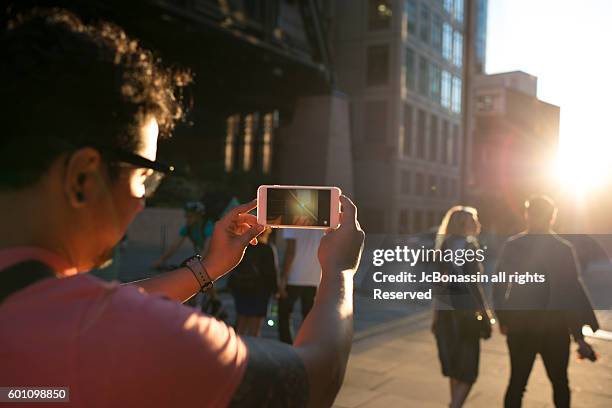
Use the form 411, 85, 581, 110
432, 206, 491, 408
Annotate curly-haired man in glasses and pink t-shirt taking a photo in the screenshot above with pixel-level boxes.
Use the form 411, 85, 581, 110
0, 9, 364, 407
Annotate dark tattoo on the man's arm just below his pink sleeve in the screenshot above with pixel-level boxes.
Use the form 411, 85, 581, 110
230, 337, 309, 407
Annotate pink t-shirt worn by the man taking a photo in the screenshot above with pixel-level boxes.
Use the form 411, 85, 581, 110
0, 248, 247, 407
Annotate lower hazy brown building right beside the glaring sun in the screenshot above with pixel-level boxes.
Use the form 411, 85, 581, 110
466, 71, 560, 234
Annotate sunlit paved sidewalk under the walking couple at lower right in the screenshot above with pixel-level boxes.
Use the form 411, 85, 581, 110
334, 311, 612, 408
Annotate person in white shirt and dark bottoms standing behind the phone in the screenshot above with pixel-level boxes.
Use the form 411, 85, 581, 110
278, 228, 323, 344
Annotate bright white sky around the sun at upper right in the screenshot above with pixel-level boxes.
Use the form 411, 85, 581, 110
486, 0, 612, 190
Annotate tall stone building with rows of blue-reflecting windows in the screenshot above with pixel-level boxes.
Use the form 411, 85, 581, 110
332, 0, 486, 233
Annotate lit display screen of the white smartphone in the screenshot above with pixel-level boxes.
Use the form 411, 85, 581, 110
266, 187, 331, 227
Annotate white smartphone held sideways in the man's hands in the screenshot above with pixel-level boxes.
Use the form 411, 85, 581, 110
257, 185, 342, 229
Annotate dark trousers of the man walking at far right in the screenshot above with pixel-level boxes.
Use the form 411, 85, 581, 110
504, 329, 570, 408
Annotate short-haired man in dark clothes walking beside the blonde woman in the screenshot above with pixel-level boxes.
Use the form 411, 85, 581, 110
493, 196, 599, 408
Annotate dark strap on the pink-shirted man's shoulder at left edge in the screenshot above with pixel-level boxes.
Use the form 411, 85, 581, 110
0, 261, 55, 303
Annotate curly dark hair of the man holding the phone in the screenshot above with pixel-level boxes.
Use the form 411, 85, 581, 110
0, 8, 191, 190
